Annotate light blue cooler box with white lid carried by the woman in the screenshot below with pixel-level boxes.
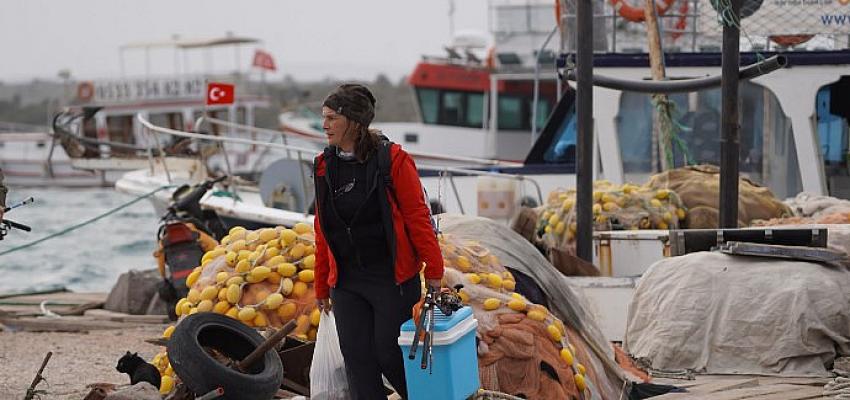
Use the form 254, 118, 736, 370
398, 307, 479, 400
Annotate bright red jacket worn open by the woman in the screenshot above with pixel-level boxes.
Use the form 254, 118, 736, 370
313, 144, 443, 299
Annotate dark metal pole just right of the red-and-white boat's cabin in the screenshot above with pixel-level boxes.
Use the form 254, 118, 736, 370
576, 0, 593, 262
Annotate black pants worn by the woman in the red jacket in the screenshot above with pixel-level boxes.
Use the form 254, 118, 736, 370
331, 275, 421, 400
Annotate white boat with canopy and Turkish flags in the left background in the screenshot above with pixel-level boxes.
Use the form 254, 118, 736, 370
47, 33, 314, 184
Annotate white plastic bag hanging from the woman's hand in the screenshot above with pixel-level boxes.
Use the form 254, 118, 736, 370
310, 312, 351, 400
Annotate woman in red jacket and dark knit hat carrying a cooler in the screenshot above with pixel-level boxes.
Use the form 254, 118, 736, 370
314, 85, 443, 400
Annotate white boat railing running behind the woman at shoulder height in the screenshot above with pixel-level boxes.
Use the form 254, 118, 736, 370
136, 115, 543, 213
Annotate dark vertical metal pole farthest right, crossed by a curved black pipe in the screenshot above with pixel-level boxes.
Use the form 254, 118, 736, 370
720, 0, 742, 228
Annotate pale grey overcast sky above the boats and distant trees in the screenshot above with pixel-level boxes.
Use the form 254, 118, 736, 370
0, 0, 488, 82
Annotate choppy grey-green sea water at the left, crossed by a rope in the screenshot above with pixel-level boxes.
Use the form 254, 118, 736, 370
0, 187, 159, 294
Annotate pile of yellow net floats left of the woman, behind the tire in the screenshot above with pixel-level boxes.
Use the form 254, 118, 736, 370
151, 223, 319, 394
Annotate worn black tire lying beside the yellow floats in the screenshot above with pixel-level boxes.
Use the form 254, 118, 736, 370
167, 313, 283, 400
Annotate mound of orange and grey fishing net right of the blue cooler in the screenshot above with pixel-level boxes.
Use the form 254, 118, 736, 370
438, 214, 624, 399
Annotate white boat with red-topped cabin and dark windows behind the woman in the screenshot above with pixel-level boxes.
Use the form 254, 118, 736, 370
280, 0, 561, 162
